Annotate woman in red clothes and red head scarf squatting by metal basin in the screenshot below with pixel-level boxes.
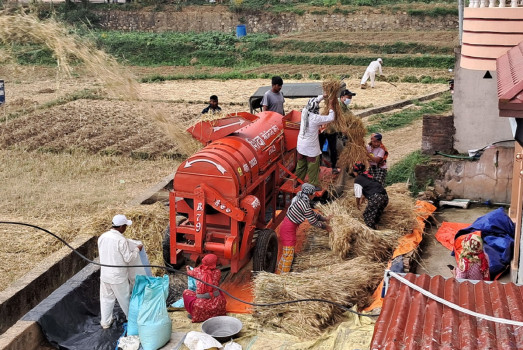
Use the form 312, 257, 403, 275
183, 254, 226, 322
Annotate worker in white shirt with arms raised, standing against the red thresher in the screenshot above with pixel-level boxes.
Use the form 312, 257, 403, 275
296, 95, 335, 191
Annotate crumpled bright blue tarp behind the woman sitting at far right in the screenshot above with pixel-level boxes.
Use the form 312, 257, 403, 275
454, 208, 515, 279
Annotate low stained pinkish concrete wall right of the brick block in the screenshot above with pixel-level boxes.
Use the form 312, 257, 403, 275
435, 147, 514, 203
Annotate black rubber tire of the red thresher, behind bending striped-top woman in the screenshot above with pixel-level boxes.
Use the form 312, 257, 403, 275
252, 229, 278, 273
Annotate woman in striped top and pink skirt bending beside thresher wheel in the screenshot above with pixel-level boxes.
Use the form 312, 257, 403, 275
276, 183, 331, 273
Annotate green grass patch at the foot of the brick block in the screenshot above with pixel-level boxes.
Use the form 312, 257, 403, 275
385, 150, 431, 195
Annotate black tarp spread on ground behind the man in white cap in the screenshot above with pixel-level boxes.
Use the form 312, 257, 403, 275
22, 264, 125, 350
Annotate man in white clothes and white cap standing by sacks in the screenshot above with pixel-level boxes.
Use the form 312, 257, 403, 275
98, 214, 143, 328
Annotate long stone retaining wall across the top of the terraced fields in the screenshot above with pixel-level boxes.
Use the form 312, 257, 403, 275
97, 5, 458, 34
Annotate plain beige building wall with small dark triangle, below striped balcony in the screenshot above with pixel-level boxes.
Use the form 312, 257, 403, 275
453, 64, 513, 153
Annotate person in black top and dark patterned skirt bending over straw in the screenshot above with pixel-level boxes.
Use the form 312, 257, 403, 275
352, 162, 389, 230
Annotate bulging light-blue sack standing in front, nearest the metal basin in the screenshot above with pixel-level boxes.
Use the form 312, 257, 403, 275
137, 275, 172, 350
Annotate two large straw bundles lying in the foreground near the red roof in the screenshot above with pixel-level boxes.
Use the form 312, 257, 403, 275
253, 257, 385, 338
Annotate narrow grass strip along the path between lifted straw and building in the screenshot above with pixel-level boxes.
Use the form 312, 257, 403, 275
367, 92, 452, 133
